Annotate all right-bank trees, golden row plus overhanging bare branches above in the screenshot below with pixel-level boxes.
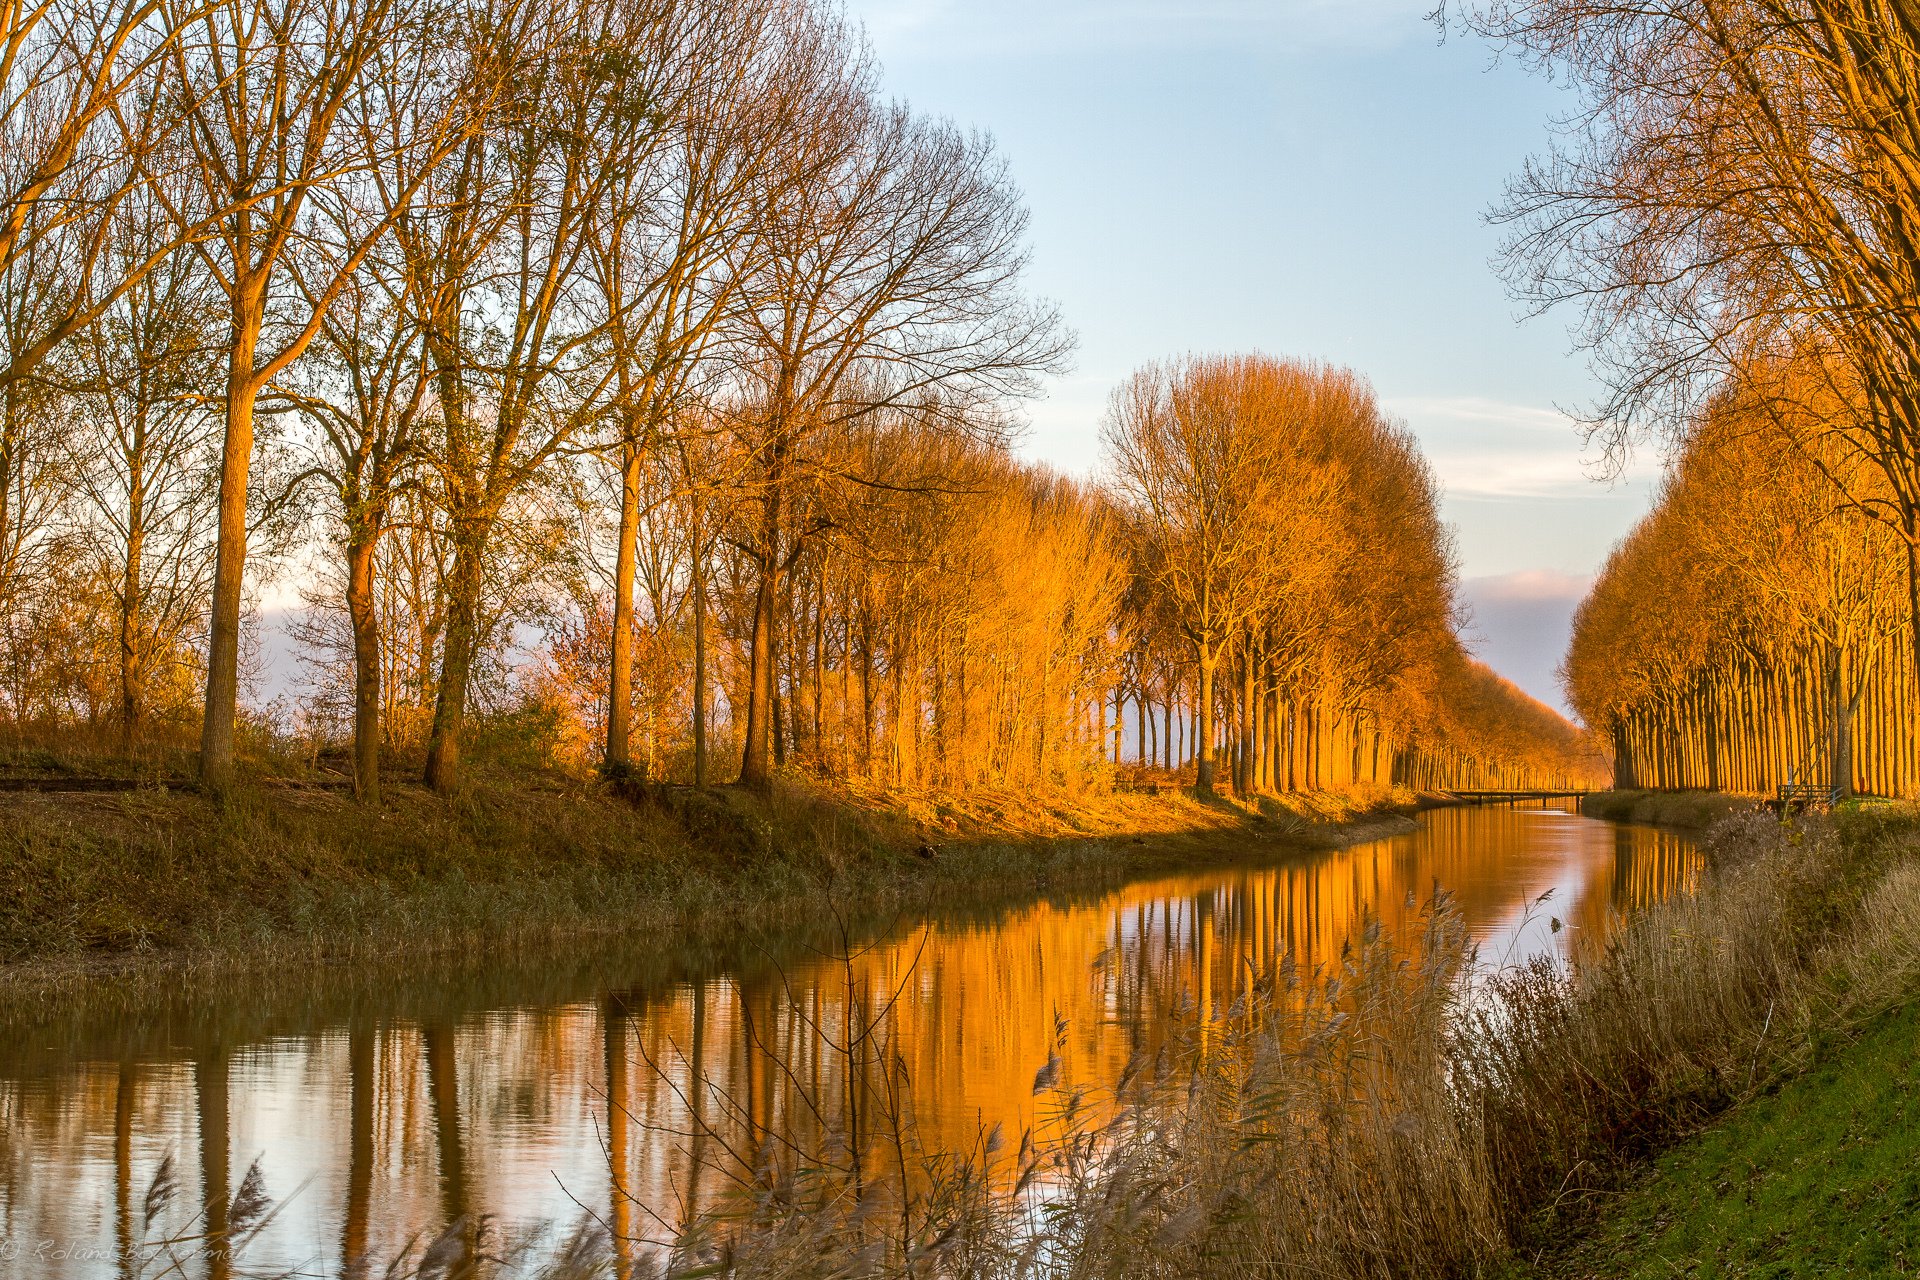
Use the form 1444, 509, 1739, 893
1463, 0, 1920, 794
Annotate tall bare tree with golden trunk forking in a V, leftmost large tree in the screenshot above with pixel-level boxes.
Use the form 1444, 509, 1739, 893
154, 0, 484, 789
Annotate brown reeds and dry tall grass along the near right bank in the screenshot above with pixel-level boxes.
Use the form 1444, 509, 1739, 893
645, 810, 1920, 1276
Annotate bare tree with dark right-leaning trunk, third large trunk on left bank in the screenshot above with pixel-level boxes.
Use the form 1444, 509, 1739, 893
401, 0, 683, 791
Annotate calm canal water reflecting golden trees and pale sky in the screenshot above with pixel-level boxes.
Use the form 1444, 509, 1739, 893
0, 806, 1697, 1280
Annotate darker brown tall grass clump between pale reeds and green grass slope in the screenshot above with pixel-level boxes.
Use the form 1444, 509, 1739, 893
1450, 814, 1889, 1236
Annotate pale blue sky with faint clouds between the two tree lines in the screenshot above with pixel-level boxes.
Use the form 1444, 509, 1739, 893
847, 0, 1659, 710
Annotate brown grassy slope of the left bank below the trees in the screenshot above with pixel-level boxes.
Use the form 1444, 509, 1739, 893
0, 771, 1413, 990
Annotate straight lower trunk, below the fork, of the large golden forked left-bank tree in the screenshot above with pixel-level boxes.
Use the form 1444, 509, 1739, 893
200, 307, 261, 793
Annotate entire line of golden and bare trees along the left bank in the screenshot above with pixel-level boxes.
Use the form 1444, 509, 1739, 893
0, 0, 1584, 802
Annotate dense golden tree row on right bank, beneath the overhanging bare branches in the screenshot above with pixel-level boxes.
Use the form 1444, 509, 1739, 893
1565, 360, 1920, 794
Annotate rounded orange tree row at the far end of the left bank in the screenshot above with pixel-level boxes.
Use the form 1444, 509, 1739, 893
1106, 355, 1601, 793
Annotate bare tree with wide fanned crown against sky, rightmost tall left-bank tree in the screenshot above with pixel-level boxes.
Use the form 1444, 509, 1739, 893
730, 42, 1069, 787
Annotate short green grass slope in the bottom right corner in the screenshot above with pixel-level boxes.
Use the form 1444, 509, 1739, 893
1521, 1006, 1920, 1278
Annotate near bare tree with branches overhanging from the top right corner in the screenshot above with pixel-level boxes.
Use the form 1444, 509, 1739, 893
1467, 0, 1920, 736
